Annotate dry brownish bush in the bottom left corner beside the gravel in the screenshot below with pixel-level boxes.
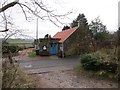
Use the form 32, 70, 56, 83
2, 59, 35, 88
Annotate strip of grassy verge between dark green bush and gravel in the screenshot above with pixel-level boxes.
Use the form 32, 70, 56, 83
74, 64, 117, 82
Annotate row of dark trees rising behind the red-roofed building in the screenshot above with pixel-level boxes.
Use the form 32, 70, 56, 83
62, 13, 118, 50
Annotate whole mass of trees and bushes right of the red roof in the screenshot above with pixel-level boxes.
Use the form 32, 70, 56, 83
63, 14, 120, 80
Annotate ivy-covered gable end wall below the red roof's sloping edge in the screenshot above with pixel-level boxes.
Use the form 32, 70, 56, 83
64, 28, 93, 56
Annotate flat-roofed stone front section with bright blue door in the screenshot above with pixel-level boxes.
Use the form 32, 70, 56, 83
35, 38, 60, 56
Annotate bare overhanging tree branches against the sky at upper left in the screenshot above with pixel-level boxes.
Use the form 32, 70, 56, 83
0, 0, 72, 62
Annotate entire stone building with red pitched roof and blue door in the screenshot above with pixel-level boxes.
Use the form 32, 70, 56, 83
35, 26, 92, 57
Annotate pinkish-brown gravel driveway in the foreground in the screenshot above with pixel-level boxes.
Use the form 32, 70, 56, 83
34, 70, 118, 90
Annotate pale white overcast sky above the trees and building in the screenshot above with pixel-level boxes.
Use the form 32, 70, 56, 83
0, 0, 119, 38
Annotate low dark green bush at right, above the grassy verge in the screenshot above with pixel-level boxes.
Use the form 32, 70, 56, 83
81, 54, 118, 73
